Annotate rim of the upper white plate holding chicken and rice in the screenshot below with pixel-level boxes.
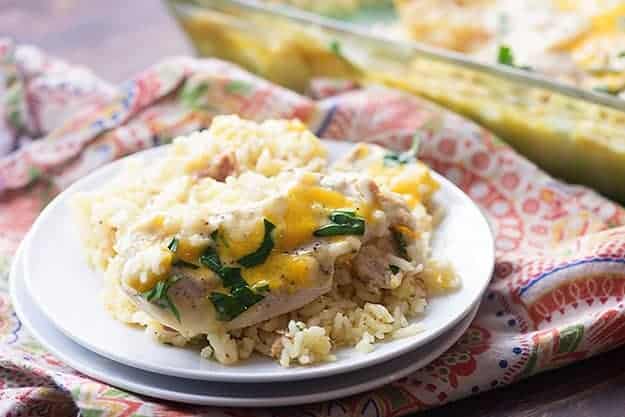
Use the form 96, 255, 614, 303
22, 139, 495, 383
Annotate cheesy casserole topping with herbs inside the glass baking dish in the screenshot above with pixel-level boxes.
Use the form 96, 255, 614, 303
395, 0, 625, 93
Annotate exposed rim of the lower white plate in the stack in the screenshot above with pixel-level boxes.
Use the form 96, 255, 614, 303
9, 239, 480, 407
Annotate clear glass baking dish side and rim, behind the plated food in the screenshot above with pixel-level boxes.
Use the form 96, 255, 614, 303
167, 0, 625, 202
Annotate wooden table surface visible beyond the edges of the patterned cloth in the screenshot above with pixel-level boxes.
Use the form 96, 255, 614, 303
0, 0, 625, 417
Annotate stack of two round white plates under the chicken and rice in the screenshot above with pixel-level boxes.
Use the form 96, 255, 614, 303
10, 141, 494, 406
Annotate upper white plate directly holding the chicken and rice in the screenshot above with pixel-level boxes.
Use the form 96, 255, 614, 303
24, 142, 494, 382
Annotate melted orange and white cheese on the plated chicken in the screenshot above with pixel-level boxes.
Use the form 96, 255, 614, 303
126, 172, 377, 292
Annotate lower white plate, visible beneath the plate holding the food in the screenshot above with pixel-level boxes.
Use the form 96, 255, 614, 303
10, 242, 478, 407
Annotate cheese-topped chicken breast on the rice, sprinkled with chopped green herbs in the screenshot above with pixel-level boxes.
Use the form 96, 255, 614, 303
118, 172, 414, 338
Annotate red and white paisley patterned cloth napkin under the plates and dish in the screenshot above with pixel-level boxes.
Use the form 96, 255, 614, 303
0, 40, 625, 417
